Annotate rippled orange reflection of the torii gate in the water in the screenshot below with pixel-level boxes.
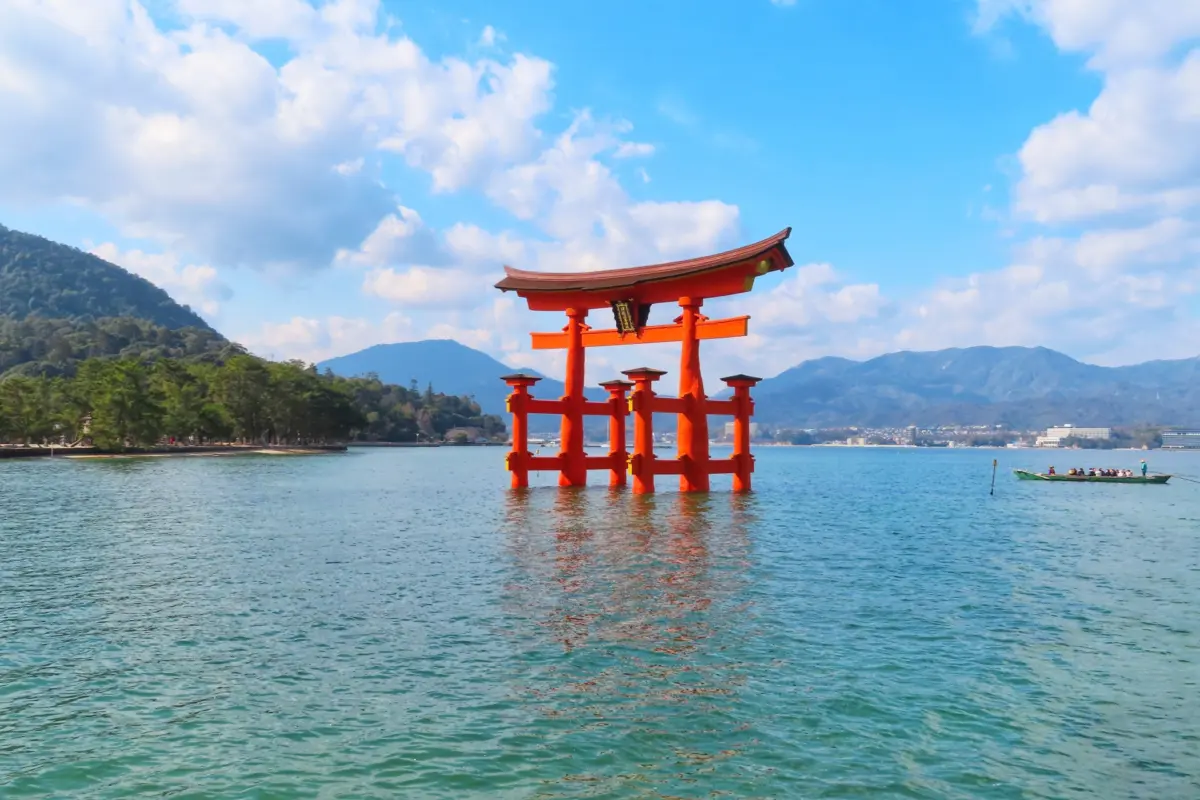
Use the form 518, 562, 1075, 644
494, 489, 770, 796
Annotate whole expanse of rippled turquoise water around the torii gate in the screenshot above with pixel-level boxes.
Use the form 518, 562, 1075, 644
0, 449, 1200, 799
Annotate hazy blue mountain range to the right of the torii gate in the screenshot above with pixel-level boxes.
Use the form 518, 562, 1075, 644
755, 347, 1200, 428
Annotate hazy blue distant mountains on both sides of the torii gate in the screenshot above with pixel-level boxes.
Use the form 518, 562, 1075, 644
318, 339, 1200, 428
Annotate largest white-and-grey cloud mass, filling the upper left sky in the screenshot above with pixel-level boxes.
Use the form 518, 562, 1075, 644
0, 0, 551, 266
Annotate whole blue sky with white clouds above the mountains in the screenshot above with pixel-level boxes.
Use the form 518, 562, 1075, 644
0, 0, 1200, 388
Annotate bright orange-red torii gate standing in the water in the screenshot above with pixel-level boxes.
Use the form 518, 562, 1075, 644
496, 228, 794, 494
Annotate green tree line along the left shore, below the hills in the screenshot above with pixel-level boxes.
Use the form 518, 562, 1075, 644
0, 354, 504, 450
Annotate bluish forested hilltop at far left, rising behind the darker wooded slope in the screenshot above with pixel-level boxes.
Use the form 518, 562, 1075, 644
0, 220, 212, 331
